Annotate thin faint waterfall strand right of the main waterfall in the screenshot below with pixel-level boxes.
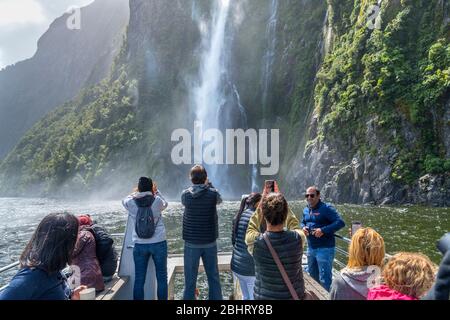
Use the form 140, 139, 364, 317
262, 0, 278, 128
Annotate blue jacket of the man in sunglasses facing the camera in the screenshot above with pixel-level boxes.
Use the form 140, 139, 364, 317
301, 201, 345, 249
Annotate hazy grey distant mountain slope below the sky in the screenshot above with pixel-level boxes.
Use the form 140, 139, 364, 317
0, 0, 129, 159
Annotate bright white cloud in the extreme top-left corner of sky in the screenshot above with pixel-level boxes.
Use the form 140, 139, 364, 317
0, 0, 48, 28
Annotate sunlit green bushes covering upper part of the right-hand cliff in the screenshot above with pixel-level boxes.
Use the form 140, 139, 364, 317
311, 0, 450, 184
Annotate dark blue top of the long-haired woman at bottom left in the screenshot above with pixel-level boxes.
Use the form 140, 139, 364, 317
0, 268, 70, 300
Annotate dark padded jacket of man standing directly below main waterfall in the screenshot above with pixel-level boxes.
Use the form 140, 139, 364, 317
181, 184, 222, 245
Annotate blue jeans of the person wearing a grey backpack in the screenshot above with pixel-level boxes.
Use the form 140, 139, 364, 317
133, 241, 168, 300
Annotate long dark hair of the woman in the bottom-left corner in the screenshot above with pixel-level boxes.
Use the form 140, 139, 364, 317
20, 213, 78, 273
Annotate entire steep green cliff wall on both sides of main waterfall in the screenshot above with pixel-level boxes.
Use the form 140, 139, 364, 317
0, 0, 450, 206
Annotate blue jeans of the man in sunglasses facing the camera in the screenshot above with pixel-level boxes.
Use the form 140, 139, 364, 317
307, 248, 336, 291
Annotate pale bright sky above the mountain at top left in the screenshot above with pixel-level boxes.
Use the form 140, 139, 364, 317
0, 0, 94, 69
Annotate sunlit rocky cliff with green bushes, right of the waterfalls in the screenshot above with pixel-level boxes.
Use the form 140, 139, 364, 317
285, 1, 450, 206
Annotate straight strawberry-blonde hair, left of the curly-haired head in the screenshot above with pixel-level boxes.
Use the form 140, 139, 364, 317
347, 228, 385, 269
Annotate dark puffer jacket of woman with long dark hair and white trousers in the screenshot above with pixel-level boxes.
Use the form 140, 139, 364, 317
231, 209, 255, 276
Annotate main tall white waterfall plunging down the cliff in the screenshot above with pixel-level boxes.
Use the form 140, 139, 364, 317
191, 0, 257, 196
